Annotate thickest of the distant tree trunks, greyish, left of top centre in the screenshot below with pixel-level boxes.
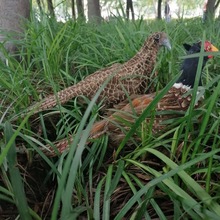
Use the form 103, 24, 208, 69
88, 0, 102, 23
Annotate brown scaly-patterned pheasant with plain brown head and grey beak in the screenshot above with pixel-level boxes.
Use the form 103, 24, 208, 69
24, 32, 171, 117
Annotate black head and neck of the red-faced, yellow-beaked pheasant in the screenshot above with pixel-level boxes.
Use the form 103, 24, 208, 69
176, 41, 218, 88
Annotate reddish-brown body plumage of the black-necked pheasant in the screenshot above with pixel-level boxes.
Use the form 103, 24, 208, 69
40, 84, 201, 156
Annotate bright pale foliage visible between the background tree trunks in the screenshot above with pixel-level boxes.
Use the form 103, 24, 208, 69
33, 0, 210, 19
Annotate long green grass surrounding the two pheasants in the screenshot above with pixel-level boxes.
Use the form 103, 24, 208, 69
0, 10, 220, 220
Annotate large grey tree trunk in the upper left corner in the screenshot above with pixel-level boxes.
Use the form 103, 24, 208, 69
0, 0, 30, 58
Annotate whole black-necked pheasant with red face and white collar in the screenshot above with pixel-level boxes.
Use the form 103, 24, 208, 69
39, 41, 218, 156
